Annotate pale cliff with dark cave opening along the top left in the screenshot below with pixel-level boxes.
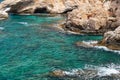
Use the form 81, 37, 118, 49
0, 0, 79, 13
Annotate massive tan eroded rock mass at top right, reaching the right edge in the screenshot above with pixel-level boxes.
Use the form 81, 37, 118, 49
64, 0, 120, 34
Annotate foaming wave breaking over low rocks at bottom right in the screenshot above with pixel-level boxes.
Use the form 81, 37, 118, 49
49, 64, 120, 80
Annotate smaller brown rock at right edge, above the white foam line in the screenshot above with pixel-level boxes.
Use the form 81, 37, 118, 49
98, 26, 120, 50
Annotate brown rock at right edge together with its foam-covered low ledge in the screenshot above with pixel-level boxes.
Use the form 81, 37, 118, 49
76, 26, 120, 51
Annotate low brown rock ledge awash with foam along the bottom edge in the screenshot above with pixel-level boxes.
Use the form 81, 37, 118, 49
48, 68, 120, 80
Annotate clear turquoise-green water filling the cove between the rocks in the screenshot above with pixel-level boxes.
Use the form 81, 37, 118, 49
0, 15, 120, 80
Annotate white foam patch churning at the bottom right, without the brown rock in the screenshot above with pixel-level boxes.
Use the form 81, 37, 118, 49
64, 64, 120, 77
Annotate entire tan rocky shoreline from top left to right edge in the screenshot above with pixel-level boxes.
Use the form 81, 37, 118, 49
0, 0, 120, 50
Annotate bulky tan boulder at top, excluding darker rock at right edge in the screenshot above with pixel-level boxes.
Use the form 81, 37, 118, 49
65, 0, 109, 34
